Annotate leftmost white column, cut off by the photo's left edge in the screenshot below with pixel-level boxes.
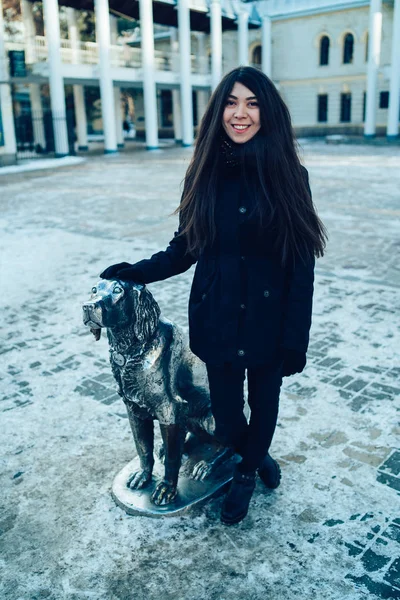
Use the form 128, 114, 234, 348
0, 0, 17, 166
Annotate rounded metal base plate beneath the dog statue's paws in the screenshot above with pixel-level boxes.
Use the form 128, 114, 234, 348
111, 445, 239, 518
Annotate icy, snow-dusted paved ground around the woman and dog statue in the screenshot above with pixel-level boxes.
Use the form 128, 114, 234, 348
0, 140, 400, 600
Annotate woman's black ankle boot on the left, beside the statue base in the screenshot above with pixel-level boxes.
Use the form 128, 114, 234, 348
221, 468, 256, 525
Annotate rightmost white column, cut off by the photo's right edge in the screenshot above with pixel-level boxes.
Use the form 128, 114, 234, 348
387, 0, 400, 139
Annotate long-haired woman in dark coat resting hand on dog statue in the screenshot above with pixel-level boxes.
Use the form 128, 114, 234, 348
101, 67, 326, 524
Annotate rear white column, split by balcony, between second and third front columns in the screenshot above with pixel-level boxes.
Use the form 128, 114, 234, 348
67, 8, 89, 152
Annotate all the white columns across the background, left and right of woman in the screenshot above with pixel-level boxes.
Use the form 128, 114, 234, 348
0, 0, 400, 162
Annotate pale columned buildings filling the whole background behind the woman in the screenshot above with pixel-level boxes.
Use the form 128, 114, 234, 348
0, 0, 400, 165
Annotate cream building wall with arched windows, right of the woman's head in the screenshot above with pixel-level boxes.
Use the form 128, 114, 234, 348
251, 3, 400, 135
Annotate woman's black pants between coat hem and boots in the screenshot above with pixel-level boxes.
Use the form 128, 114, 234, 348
207, 363, 282, 472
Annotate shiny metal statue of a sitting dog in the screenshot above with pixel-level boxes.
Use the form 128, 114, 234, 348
83, 279, 233, 505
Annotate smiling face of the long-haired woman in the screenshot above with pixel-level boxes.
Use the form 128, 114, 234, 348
222, 81, 261, 144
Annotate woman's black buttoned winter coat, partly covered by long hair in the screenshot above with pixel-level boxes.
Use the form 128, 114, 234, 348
133, 168, 315, 367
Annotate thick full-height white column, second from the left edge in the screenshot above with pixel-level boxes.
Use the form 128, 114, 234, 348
43, 0, 69, 157
